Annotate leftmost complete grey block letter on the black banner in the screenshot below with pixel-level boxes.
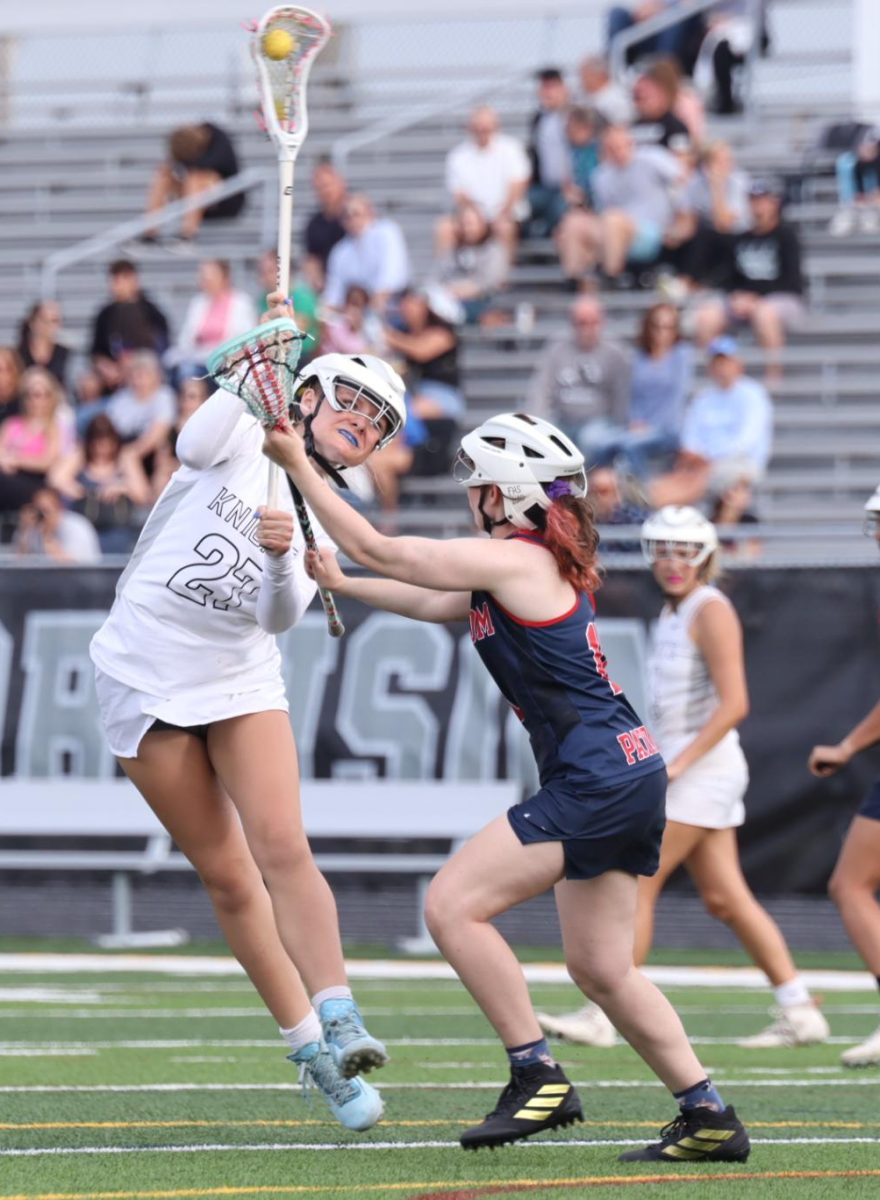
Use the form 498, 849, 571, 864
16, 611, 114, 776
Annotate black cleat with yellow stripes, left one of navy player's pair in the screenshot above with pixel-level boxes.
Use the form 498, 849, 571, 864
460, 1063, 583, 1150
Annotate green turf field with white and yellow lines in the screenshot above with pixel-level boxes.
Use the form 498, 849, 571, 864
0, 956, 880, 1200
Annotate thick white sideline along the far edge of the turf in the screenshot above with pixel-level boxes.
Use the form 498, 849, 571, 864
0, 954, 876, 991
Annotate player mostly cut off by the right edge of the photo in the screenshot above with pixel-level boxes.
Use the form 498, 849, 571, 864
809, 487, 880, 1067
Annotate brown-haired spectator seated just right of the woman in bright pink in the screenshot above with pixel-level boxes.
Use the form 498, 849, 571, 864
49, 413, 152, 554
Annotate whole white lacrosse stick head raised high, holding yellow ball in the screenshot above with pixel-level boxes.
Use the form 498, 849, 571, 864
251, 5, 330, 155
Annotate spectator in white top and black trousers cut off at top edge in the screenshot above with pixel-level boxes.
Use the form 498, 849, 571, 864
694, 0, 767, 116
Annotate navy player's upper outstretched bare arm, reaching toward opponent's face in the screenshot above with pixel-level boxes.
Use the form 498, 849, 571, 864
264, 430, 522, 592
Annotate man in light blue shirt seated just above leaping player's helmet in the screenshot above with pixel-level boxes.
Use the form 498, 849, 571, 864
322, 194, 409, 313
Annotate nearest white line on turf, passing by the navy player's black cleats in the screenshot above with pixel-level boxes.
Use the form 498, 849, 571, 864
0, 1138, 876, 1158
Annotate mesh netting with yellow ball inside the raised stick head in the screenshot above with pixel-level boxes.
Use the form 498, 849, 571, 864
253, 8, 328, 134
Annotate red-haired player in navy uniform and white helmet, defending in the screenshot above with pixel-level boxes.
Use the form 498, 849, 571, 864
265, 413, 749, 1162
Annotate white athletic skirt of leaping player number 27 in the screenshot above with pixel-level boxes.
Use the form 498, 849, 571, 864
95, 667, 288, 758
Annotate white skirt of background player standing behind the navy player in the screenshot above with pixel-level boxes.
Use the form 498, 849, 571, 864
666, 739, 749, 829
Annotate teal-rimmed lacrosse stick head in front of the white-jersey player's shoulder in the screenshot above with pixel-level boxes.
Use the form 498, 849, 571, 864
208, 317, 304, 430
